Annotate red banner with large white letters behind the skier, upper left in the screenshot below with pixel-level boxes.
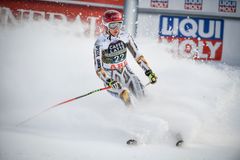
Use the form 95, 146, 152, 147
0, 0, 123, 36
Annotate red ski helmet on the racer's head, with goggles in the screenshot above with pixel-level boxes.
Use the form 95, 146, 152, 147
102, 10, 123, 29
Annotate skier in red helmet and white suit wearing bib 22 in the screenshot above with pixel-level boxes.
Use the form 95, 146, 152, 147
94, 10, 157, 106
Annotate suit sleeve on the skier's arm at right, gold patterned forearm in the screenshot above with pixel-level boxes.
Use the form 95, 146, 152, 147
127, 35, 150, 72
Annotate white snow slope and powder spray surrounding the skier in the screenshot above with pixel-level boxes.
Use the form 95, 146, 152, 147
0, 22, 240, 160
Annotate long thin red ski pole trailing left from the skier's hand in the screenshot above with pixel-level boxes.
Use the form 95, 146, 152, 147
16, 86, 111, 126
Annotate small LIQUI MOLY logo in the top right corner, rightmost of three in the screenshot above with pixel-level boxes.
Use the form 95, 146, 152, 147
218, 0, 237, 13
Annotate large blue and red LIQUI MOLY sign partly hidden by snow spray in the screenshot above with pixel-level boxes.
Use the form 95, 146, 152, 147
159, 16, 224, 61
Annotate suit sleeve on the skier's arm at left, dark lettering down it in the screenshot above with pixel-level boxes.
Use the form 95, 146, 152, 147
93, 41, 110, 82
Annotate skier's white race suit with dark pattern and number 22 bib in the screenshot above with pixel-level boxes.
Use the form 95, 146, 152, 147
94, 30, 150, 102
